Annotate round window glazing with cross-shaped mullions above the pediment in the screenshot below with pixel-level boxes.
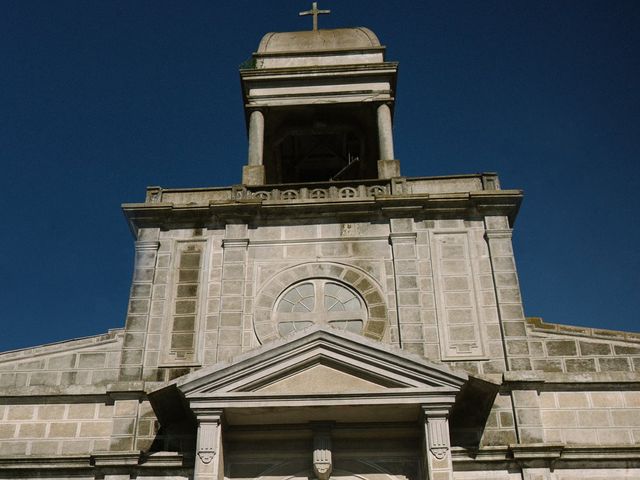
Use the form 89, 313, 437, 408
274, 278, 367, 336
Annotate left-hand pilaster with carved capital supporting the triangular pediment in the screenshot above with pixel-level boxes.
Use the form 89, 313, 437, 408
193, 407, 224, 480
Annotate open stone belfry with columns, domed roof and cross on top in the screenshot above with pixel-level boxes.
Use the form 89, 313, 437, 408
240, 13, 400, 185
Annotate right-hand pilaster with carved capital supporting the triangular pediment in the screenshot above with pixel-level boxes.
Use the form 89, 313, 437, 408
423, 407, 453, 480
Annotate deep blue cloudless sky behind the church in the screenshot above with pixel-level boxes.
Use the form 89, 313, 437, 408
0, 0, 640, 351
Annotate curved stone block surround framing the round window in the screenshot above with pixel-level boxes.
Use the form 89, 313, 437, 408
253, 263, 388, 343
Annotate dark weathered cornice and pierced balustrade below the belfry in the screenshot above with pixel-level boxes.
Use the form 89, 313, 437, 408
122, 175, 523, 234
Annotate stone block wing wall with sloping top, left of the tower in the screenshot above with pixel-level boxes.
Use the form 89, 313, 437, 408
0, 330, 123, 456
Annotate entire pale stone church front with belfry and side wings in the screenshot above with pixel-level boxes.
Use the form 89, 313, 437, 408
0, 20, 640, 480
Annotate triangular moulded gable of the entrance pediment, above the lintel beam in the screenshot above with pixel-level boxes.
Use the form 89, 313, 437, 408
176, 327, 467, 398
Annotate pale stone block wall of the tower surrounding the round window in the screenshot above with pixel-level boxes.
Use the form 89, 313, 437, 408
119, 217, 524, 381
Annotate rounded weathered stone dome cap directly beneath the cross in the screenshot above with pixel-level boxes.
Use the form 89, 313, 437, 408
257, 27, 380, 54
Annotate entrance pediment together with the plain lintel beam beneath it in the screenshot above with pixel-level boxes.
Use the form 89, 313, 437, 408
148, 327, 495, 424
